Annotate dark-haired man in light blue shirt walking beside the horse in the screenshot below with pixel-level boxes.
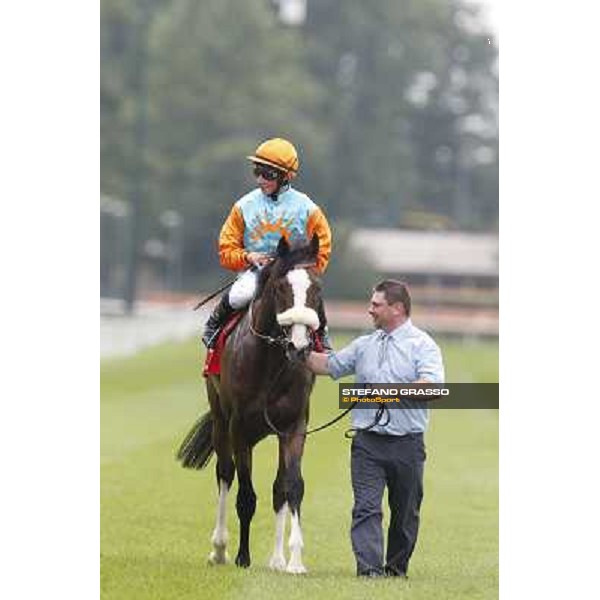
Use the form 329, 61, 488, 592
306, 279, 444, 577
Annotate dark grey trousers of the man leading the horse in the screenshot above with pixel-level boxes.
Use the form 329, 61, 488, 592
350, 432, 425, 575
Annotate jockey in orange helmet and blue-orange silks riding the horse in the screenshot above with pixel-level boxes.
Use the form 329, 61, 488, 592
202, 138, 332, 351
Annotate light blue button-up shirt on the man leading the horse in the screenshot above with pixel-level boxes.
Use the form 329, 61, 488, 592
327, 319, 444, 435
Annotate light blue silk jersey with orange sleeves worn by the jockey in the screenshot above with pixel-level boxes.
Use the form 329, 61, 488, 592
219, 186, 331, 273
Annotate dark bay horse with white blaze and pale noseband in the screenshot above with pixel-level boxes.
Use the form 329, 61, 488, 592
178, 235, 322, 573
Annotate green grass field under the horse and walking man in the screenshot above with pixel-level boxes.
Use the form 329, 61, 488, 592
101, 337, 498, 600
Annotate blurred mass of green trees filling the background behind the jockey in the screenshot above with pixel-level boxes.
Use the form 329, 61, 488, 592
101, 0, 498, 288
